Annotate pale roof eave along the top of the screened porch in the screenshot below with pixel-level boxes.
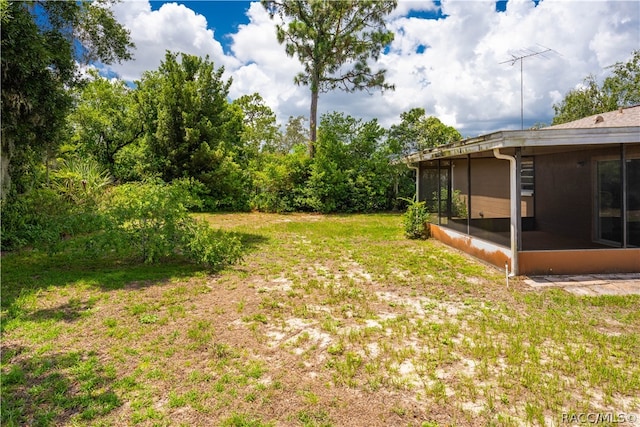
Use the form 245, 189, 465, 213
404, 126, 640, 163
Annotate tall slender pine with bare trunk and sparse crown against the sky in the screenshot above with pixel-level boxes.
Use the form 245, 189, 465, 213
262, 0, 397, 157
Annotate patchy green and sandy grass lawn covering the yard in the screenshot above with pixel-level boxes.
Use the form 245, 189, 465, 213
1, 214, 640, 426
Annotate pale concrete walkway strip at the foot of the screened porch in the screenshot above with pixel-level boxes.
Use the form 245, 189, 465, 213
524, 273, 640, 296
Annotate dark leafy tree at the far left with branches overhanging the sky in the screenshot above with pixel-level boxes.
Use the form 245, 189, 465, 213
0, 0, 133, 198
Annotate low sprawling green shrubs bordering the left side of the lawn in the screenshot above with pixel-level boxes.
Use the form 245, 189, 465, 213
2, 174, 241, 269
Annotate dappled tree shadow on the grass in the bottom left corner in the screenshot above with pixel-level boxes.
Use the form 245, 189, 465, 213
0, 347, 122, 426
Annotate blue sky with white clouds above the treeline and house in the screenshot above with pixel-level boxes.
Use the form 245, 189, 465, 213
109, 0, 640, 136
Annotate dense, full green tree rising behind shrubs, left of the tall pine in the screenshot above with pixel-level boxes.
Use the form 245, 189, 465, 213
139, 52, 248, 208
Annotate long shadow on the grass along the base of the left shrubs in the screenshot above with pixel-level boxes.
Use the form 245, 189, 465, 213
0, 233, 268, 331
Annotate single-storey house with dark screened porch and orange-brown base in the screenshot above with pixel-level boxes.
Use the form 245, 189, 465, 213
405, 105, 640, 275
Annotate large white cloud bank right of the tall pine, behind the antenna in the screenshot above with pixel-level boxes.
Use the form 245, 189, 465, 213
372, 0, 640, 136
